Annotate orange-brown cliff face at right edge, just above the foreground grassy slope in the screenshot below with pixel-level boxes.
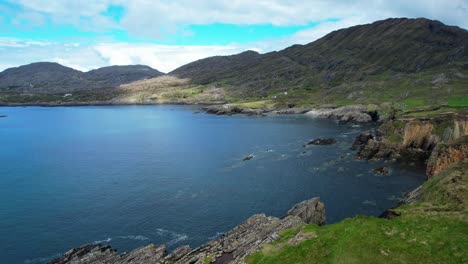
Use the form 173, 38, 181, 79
426, 136, 468, 178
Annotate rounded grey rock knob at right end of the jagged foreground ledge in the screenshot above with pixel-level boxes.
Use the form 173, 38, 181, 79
288, 197, 326, 225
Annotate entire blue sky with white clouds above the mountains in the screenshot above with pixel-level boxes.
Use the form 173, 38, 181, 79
0, 0, 468, 72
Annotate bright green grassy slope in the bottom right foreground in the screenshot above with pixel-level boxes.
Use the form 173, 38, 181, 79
246, 162, 468, 264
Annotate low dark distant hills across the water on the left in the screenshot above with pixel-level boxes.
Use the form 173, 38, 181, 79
0, 62, 164, 93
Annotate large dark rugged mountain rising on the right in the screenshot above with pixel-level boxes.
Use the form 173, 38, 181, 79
169, 18, 468, 97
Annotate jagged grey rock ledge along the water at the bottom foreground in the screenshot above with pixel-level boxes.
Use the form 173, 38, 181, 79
49, 197, 326, 264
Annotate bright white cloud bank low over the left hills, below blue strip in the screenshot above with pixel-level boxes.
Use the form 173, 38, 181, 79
0, 38, 245, 72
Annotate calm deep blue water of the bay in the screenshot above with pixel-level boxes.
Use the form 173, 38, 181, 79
0, 106, 425, 264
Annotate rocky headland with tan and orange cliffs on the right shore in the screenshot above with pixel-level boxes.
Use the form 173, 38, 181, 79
353, 114, 468, 167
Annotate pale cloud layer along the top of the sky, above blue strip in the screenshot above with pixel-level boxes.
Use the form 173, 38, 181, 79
8, 0, 468, 38
